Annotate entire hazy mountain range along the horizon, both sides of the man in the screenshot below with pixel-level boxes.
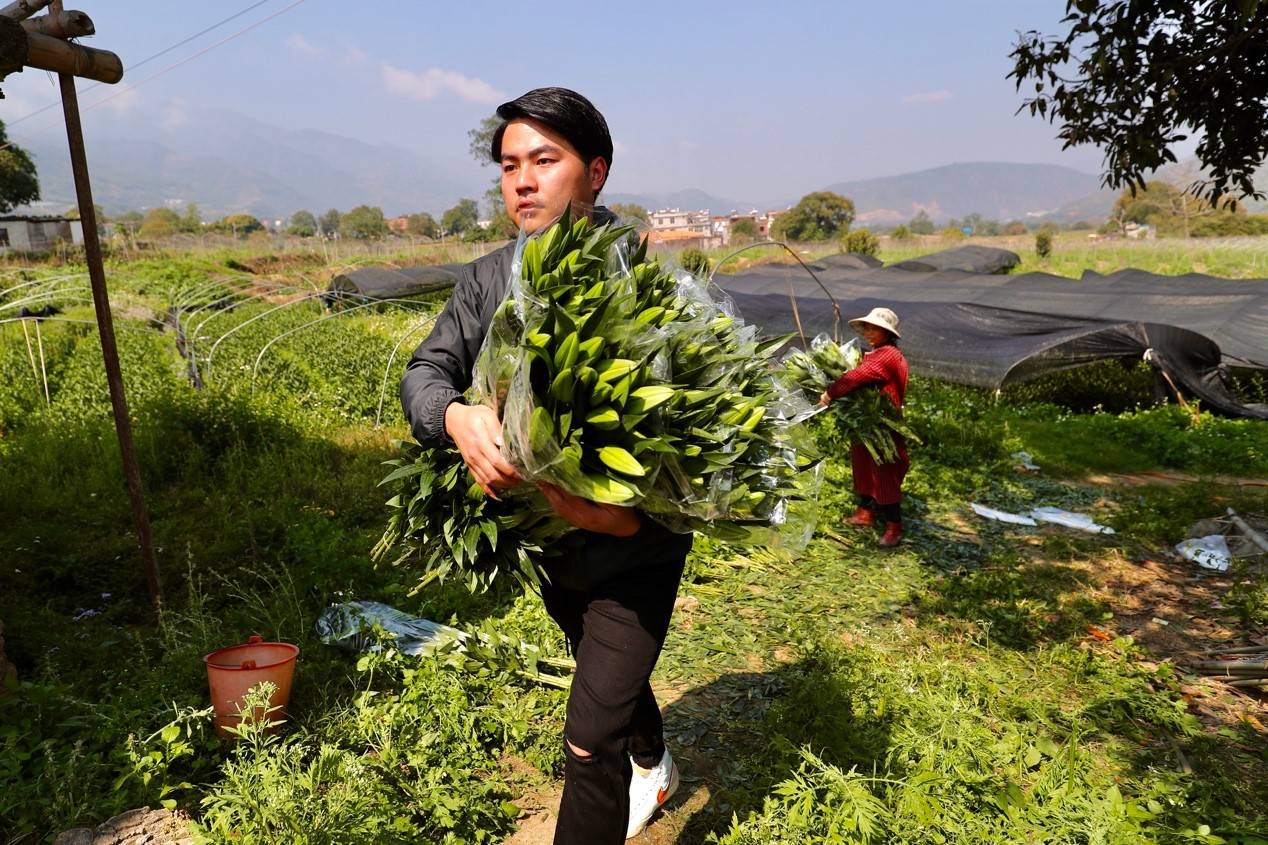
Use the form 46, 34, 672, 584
13, 112, 1141, 226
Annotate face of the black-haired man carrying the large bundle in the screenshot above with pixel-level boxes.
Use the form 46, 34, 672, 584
500, 119, 607, 232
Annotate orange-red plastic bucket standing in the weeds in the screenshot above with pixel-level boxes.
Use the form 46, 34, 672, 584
203, 637, 299, 736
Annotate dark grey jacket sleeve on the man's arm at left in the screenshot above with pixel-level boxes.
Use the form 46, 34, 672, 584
401, 264, 487, 443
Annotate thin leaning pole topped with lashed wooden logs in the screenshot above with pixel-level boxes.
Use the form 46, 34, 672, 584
0, 0, 162, 610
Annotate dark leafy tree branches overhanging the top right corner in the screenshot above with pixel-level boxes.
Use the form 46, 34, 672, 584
1008, 0, 1268, 206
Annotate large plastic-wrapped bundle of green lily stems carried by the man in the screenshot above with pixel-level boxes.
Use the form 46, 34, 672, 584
380, 211, 820, 584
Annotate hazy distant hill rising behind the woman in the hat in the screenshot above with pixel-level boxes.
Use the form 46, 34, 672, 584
824, 161, 1099, 225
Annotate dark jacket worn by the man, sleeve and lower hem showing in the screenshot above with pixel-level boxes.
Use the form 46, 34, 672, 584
401, 215, 691, 590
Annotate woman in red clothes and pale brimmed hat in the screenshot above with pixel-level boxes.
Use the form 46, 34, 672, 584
819, 308, 908, 547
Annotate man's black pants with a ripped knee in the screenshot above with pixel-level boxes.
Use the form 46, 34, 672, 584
541, 553, 685, 845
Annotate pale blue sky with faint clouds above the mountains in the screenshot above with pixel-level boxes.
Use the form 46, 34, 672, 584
0, 0, 1101, 199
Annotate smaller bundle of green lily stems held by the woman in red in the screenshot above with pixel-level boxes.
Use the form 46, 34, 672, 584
782, 335, 919, 463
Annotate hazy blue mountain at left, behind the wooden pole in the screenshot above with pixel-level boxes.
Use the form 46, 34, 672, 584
13, 105, 488, 218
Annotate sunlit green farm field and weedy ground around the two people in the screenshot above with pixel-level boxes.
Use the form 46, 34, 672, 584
0, 236, 1268, 845
